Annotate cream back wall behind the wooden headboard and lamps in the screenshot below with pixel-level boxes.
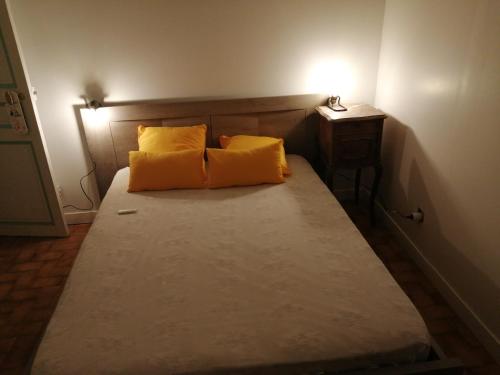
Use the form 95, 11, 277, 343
7, 0, 384, 210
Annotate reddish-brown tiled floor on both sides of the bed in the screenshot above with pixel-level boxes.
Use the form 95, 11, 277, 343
0, 210, 500, 374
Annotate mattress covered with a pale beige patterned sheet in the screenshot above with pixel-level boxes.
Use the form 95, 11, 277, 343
32, 155, 430, 375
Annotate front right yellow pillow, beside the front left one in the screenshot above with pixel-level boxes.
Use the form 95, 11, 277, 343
207, 142, 285, 188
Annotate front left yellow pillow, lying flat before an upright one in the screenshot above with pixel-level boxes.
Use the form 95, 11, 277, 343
128, 150, 206, 193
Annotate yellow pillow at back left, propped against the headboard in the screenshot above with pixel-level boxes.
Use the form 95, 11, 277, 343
137, 125, 207, 152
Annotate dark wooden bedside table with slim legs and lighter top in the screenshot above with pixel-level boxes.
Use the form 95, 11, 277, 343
316, 104, 387, 224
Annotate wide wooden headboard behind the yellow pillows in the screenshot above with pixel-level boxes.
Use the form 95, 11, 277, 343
80, 95, 326, 198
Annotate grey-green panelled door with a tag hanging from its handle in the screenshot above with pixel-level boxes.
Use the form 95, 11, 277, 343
0, 0, 68, 236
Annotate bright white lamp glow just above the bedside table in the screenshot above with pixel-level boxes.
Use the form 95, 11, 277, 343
307, 59, 356, 100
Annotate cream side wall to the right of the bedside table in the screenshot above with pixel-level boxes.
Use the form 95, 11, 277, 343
376, 0, 500, 358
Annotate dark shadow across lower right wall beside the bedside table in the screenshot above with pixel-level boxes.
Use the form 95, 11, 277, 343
381, 117, 500, 346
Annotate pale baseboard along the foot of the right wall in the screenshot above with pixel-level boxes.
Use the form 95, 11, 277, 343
376, 202, 500, 363
